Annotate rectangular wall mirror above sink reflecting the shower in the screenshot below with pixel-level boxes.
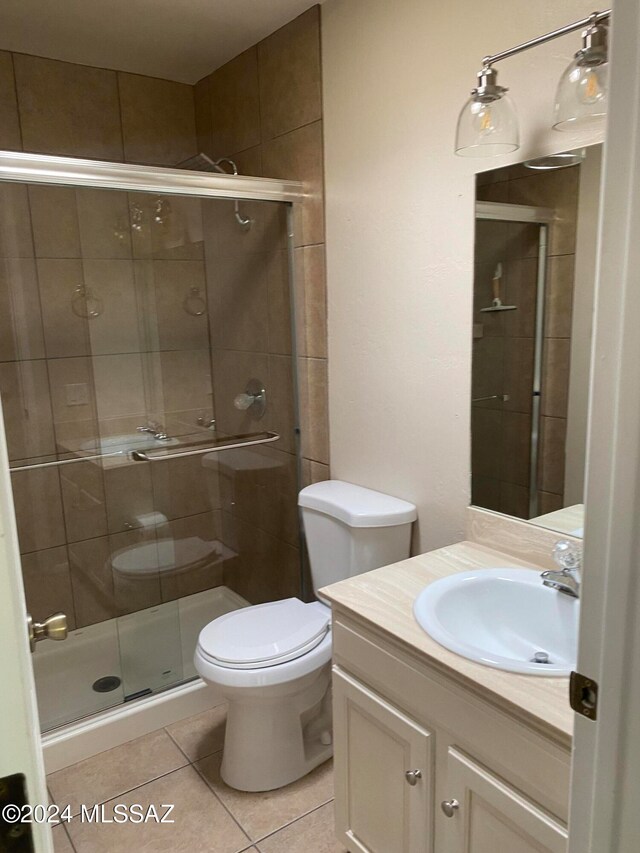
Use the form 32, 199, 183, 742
471, 145, 601, 536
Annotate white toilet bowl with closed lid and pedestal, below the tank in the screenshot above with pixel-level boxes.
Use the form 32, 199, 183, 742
195, 598, 332, 791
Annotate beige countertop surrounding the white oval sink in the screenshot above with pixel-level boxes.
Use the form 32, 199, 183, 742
321, 542, 574, 740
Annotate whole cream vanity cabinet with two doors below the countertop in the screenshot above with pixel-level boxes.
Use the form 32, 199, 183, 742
333, 610, 570, 853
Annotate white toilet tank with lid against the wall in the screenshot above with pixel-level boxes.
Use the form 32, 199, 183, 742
298, 480, 417, 592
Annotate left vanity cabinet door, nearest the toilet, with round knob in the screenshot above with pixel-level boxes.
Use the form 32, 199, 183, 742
333, 668, 433, 853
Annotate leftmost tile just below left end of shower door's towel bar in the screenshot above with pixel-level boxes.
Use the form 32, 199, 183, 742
11, 468, 66, 553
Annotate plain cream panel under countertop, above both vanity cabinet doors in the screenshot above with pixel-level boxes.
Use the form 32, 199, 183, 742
333, 613, 571, 822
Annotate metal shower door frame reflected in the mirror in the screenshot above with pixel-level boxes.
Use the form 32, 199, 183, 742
475, 201, 555, 519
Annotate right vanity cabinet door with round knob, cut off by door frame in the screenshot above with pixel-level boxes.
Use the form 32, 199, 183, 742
440, 747, 567, 853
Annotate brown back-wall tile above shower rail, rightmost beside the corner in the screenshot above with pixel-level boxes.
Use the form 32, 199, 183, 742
118, 72, 196, 166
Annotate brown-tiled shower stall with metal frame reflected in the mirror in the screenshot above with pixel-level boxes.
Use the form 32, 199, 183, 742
471, 201, 555, 518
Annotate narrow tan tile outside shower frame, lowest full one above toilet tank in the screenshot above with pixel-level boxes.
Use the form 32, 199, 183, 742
298, 358, 329, 465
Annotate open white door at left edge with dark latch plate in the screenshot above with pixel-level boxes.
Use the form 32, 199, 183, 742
0, 404, 53, 853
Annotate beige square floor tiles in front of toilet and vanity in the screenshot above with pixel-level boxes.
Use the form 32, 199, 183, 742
48, 708, 345, 853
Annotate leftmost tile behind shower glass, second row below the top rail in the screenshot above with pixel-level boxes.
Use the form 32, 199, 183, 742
0, 258, 44, 361
